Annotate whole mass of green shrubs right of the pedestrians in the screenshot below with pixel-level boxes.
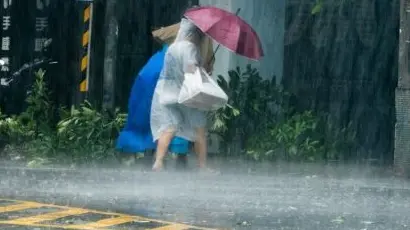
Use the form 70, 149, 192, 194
211, 65, 355, 161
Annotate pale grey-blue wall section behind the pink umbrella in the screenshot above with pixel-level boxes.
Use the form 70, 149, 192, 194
199, 0, 285, 80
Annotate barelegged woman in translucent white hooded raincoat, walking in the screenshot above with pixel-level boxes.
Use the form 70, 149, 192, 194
151, 18, 215, 171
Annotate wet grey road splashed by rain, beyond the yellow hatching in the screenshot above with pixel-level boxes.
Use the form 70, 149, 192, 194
0, 162, 410, 230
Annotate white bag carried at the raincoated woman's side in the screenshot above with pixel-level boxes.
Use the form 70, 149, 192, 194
178, 68, 228, 111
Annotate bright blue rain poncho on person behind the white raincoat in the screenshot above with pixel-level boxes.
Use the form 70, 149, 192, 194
116, 46, 188, 153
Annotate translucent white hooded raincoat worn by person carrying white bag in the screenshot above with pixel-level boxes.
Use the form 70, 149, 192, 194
151, 19, 206, 141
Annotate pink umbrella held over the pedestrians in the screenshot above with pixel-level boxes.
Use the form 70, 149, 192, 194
184, 6, 263, 60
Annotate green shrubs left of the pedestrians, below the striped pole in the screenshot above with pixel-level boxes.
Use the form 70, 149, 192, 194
0, 70, 126, 167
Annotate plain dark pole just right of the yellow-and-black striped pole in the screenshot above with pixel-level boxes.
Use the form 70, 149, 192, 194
102, 0, 118, 110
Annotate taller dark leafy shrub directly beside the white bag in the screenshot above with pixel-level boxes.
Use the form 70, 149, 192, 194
211, 65, 288, 155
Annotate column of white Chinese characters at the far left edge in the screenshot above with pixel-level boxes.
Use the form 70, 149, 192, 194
0, 0, 13, 73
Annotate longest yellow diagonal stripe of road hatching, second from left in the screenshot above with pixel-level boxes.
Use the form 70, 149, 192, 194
8, 209, 88, 225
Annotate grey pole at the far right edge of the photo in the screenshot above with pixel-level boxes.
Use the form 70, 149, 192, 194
394, 0, 410, 176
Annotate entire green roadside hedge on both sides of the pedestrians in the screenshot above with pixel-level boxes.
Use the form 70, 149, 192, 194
0, 66, 355, 165
